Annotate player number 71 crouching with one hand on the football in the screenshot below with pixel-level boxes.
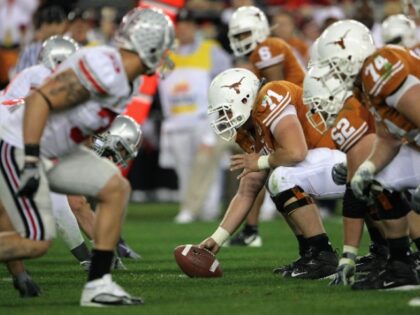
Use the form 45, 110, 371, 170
201, 69, 345, 279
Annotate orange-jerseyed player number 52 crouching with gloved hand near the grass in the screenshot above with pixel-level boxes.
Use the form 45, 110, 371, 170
303, 63, 388, 285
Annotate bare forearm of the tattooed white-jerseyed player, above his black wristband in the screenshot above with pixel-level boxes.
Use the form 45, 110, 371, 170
23, 92, 49, 144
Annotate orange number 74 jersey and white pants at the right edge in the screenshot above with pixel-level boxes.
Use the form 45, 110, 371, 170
359, 45, 420, 190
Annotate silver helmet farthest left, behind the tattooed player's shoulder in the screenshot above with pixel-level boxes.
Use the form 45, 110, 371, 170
39, 35, 79, 70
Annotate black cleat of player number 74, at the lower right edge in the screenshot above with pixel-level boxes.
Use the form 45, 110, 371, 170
351, 260, 420, 291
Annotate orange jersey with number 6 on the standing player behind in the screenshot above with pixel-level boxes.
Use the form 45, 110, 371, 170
249, 37, 305, 86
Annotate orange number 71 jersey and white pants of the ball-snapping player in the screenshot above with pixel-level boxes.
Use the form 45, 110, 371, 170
236, 81, 346, 198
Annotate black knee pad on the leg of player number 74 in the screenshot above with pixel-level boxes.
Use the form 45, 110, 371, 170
375, 189, 411, 220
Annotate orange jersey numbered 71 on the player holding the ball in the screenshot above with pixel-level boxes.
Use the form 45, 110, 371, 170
236, 81, 335, 153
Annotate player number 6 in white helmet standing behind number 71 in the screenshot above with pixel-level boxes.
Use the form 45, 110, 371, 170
225, 6, 312, 247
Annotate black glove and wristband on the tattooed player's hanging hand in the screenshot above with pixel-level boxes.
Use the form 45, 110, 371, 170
18, 145, 40, 198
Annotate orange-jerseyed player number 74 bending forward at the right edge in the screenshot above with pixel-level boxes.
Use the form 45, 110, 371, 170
318, 21, 420, 289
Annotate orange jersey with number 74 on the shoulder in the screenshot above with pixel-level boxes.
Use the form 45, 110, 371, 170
360, 45, 420, 146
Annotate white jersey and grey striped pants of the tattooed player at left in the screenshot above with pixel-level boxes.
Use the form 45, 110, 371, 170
0, 46, 131, 240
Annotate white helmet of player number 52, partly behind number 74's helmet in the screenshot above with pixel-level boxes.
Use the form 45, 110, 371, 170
303, 65, 352, 133
